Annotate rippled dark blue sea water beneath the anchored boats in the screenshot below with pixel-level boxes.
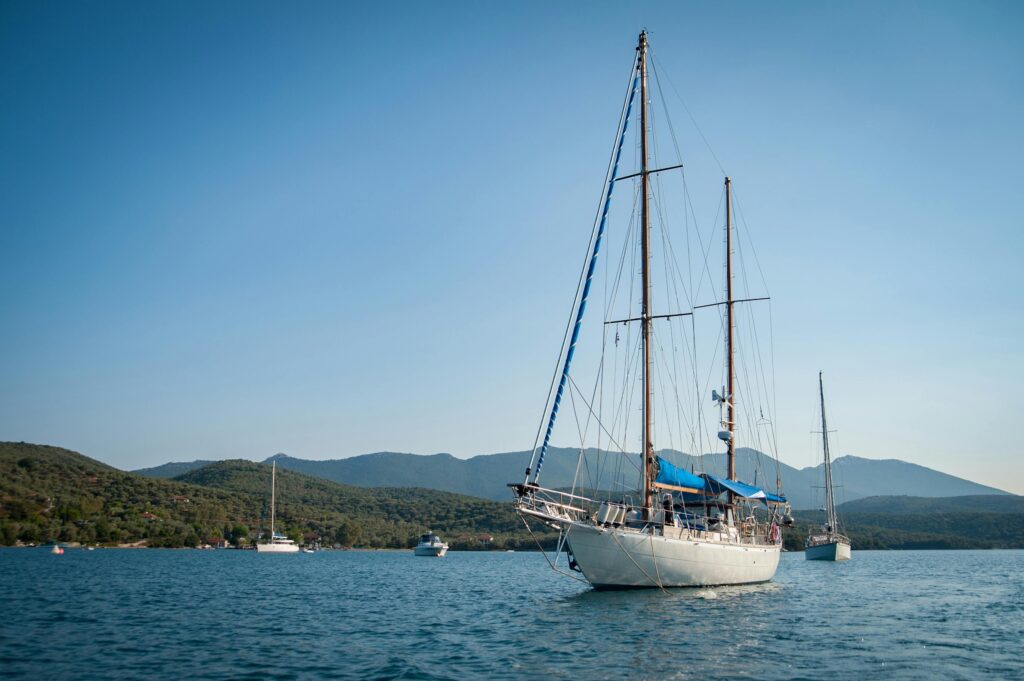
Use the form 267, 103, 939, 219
0, 548, 1024, 681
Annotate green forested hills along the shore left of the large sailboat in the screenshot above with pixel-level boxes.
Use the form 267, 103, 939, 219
0, 442, 552, 548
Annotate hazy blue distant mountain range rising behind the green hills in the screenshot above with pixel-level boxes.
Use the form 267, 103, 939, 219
137, 448, 1007, 509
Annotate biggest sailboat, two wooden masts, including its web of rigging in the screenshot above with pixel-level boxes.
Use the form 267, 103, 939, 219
510, 32, 792, 589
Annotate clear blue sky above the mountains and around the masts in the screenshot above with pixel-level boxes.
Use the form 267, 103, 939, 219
0, 2, 1024, 493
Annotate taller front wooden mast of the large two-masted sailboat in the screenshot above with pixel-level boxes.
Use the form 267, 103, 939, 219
638, 31, 654, 513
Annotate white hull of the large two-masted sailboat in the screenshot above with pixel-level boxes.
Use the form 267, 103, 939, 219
567, 522, 781, 589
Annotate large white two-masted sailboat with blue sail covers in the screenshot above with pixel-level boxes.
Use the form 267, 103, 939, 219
509, 31, 792, 590
